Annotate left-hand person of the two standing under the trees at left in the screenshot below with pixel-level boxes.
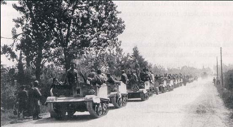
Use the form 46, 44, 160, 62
17, 86, 28, 119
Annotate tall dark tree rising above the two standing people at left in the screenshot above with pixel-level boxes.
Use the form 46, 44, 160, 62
12, 0, 57, 80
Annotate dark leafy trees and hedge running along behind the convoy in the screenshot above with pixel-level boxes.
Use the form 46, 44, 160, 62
1, 0, 210, 108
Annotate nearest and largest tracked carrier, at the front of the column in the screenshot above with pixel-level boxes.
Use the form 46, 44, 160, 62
46, 84, 110, 119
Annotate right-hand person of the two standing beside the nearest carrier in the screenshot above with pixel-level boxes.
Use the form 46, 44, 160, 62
33, 80, 42, 120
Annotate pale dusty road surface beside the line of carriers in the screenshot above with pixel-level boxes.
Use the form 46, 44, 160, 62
4, 78, 229, 127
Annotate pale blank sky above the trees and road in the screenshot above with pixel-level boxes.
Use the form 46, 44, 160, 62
1, 1, 233, 68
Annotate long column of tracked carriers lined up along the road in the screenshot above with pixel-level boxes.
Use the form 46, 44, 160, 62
46, 69, 197, 120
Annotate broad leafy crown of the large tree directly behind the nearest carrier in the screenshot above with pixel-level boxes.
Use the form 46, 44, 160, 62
51, 0, 125, 70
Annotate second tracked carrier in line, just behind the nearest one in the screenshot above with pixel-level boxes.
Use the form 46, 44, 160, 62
108, 82, 128, 108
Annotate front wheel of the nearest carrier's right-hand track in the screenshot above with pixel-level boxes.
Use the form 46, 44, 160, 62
86, 102, 103, 118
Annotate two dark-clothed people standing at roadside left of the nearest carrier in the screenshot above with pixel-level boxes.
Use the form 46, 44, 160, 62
14, 80, 42, 120
